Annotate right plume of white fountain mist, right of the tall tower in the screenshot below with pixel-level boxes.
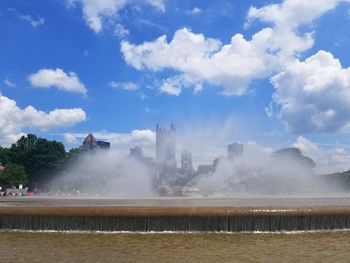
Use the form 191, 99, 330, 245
196, 146, 337, 196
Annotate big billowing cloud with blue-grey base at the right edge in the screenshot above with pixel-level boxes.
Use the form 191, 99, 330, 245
272, 51, 350, 133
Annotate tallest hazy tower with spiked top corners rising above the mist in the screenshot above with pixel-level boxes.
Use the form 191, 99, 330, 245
156, 124, 176, 163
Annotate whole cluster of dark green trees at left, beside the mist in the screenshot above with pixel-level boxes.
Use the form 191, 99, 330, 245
0, 134, 82, 187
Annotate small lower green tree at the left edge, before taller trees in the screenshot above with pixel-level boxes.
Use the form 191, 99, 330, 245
0, 164, 28, 186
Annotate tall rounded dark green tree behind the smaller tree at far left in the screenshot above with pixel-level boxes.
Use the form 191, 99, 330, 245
10, 134, 66, 184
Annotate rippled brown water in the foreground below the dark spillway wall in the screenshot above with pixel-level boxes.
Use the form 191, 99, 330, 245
0, 232, 350, 262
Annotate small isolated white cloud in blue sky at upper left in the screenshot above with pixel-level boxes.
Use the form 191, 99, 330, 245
29, 68, 87, 95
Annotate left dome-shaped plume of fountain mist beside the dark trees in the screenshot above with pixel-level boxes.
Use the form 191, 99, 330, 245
49, 149, 155, 197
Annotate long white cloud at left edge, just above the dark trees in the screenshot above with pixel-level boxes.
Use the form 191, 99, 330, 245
0, 95, 86, 145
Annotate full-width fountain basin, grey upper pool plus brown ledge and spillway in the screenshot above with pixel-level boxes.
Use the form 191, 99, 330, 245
0, 197, 350, 232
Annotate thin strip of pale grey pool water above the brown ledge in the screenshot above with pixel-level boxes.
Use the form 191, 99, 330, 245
0, 197, 350, 207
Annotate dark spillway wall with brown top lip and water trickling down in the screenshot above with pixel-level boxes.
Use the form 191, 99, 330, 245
0, 207, 350, 232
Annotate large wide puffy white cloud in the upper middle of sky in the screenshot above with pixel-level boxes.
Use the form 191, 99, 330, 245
121, 28, 276, 95
